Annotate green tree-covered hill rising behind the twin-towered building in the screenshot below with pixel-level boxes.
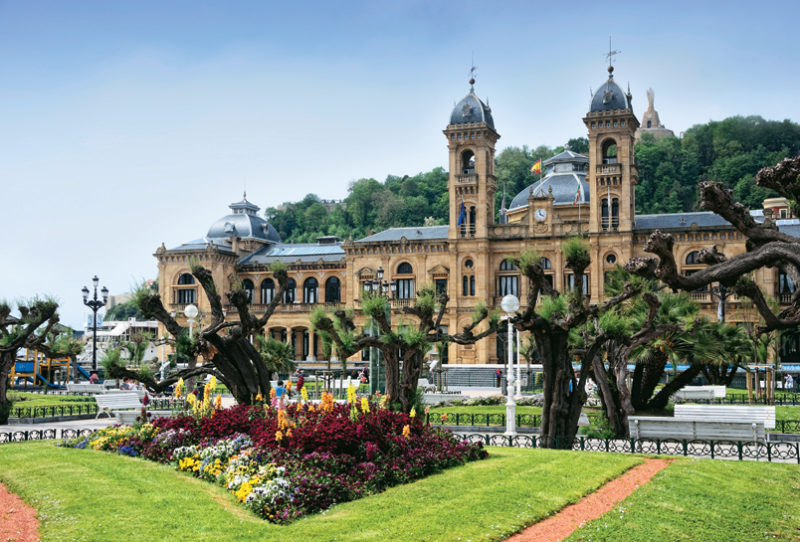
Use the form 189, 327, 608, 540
266, 116, 800, 242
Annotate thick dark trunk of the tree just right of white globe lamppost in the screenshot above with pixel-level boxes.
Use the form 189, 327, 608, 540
534, 326, 586, 449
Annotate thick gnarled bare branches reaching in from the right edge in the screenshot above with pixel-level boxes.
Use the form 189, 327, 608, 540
625, 156, 800, 352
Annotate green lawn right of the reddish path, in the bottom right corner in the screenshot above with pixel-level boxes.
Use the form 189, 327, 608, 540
568, 459, 800, 542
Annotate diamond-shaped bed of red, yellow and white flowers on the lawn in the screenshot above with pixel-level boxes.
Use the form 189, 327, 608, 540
61, 390, 487, 523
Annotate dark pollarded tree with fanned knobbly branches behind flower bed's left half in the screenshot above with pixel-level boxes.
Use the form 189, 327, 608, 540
109, 262, 289, 404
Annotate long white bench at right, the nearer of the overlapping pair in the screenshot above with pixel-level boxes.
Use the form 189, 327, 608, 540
628, 416, 766, 442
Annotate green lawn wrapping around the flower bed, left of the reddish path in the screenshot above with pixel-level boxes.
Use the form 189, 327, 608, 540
0, 443, 641, 542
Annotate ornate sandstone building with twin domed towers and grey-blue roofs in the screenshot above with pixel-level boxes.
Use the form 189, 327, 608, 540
155, 63, 800, 370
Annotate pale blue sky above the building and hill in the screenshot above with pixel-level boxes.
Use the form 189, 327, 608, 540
0, 0, 800, 329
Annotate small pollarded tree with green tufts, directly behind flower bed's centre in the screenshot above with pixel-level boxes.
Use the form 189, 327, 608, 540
311, 285, 499, 412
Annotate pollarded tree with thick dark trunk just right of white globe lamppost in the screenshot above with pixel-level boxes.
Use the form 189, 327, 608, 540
512, 243, 640, 447
